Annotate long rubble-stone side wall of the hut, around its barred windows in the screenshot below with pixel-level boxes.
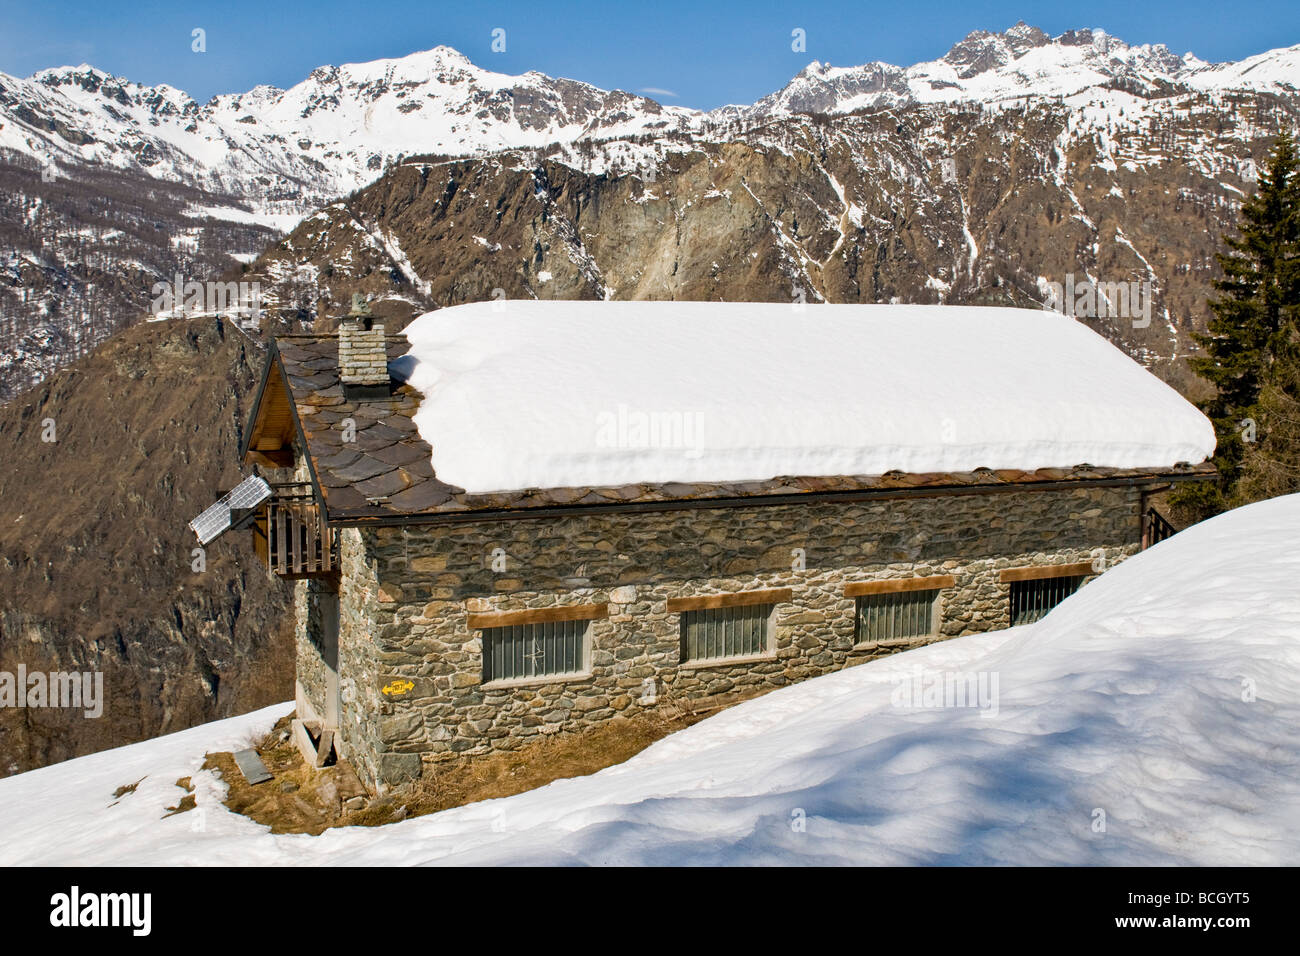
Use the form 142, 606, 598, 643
299, 488, 1140, 786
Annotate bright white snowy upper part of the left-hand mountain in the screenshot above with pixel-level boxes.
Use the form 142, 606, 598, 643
0, 47, 697, 212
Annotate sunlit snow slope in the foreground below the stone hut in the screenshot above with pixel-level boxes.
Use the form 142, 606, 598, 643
0, 496, 1300, 865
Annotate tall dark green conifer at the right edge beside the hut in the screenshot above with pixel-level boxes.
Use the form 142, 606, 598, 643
1171, 133, 1300, 520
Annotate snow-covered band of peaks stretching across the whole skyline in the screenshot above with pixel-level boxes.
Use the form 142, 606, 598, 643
0, 23, 1300, 217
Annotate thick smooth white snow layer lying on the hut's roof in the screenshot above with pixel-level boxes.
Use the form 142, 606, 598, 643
391, 300, 1214, 493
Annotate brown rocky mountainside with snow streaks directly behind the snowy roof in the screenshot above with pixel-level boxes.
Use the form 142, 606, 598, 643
241, 83, 1296, 393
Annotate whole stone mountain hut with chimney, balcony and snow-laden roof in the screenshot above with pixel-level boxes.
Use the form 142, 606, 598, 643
196, 302, 1214, 790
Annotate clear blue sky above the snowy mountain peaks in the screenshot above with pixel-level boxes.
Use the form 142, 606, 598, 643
0, 0, 1300, 109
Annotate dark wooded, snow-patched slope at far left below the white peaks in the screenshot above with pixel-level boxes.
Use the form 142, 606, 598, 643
0, 157, 281, 402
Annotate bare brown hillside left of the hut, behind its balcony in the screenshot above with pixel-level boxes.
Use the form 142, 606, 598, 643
0, 320, 293, 783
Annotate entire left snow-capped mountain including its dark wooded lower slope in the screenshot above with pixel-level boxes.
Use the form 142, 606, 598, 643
0, 47, 694, 401
